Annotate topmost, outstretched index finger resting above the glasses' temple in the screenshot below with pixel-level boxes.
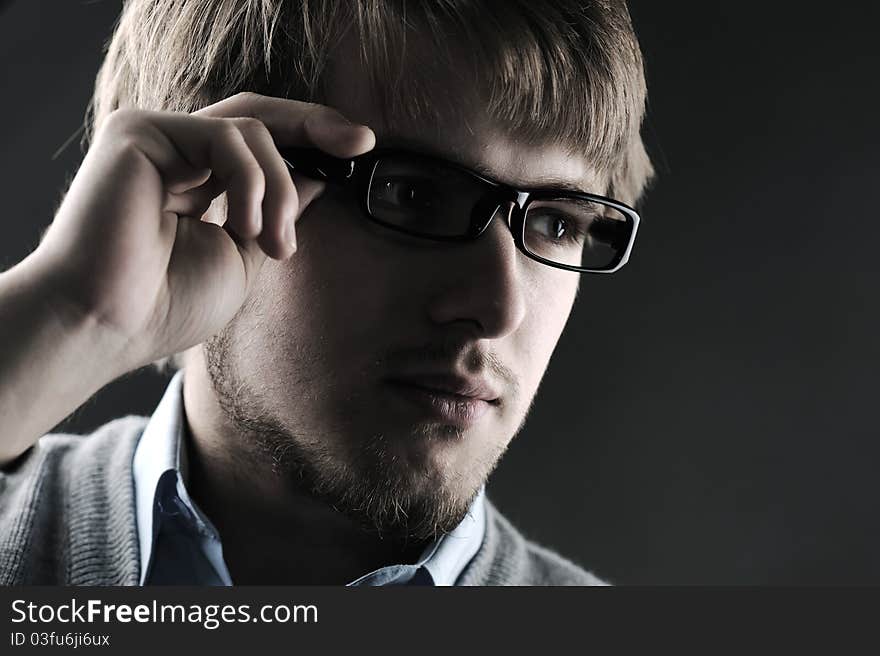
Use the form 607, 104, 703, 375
194, 93, 376, 157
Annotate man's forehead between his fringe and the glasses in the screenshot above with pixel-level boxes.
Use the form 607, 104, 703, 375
325, 40, 607, 194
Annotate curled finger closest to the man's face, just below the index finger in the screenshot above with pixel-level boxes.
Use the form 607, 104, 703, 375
230, 118, 300, 260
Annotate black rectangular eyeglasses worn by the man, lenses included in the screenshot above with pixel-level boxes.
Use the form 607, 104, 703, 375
279, 148, 640, 273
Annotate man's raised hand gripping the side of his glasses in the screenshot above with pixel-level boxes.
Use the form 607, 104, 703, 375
29, 93, 375, 371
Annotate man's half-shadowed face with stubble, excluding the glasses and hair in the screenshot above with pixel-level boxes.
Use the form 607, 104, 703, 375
206, 48, 596, 539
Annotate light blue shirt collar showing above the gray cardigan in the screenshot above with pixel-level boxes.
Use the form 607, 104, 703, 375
132, 371, 486, 586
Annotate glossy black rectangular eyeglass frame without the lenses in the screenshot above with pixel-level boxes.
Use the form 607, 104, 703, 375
278, 148, 641, 273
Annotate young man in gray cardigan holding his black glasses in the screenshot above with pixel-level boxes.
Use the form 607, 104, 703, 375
0, 0, 651, 585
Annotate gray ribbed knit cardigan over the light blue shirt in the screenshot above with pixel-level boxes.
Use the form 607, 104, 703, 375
0, 417, 603, 585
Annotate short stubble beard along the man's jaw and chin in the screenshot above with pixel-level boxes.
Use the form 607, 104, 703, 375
204, 327, 506, 548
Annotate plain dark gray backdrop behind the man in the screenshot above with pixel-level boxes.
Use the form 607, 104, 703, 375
0, 0, 880, 584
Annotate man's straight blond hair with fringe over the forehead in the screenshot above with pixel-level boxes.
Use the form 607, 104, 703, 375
86, 0, 653, 203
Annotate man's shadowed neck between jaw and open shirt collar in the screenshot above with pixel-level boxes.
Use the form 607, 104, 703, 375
183, 358, 426, 585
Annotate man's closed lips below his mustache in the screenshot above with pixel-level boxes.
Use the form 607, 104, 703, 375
386, 379, 500, 430
